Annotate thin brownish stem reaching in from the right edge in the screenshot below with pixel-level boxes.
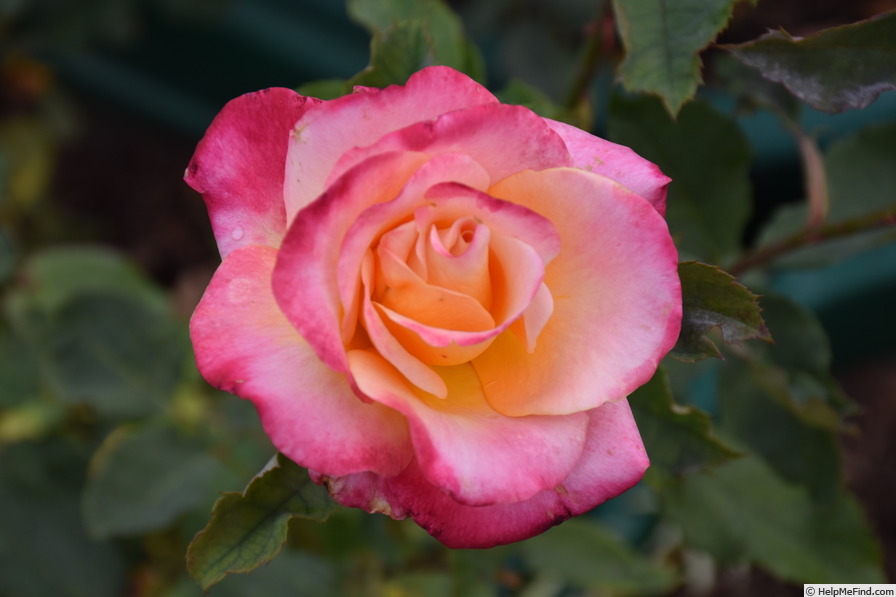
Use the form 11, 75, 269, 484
726, 207, 896, 276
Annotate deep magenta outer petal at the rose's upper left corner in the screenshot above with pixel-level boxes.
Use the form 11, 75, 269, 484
185, 88, 320, 257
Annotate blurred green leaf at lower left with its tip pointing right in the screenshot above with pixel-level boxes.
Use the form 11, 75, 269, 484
83, 426, 234, 538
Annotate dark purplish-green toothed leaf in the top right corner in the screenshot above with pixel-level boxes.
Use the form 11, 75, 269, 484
722, 12, 896, 112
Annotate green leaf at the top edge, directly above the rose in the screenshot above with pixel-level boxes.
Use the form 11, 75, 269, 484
348, 0, 484, 87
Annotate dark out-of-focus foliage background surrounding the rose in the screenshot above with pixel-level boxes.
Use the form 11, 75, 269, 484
0, 0, 896, 597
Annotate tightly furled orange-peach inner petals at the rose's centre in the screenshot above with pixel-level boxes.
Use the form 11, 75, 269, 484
362, 184, 559, 396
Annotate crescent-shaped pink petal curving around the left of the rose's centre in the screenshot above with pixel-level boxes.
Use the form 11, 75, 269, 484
273, 153, 427, 371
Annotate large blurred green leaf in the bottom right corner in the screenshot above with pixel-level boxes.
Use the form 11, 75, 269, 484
664, 458, 884, 583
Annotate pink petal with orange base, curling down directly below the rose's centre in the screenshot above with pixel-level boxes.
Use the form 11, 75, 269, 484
349, 350, 588, 505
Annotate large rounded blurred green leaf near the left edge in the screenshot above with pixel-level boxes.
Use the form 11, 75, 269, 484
6, 249, 188, 417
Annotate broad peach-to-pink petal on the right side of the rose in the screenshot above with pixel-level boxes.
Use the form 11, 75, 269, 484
473, 168, 681, 416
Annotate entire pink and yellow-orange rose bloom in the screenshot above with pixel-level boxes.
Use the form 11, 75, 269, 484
186, 67, 681, 547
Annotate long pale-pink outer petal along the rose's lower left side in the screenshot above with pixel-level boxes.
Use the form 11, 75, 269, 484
190, 245, 411, 475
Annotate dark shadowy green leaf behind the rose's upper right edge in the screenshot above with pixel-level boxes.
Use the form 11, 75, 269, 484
609, 95, 751, 263
